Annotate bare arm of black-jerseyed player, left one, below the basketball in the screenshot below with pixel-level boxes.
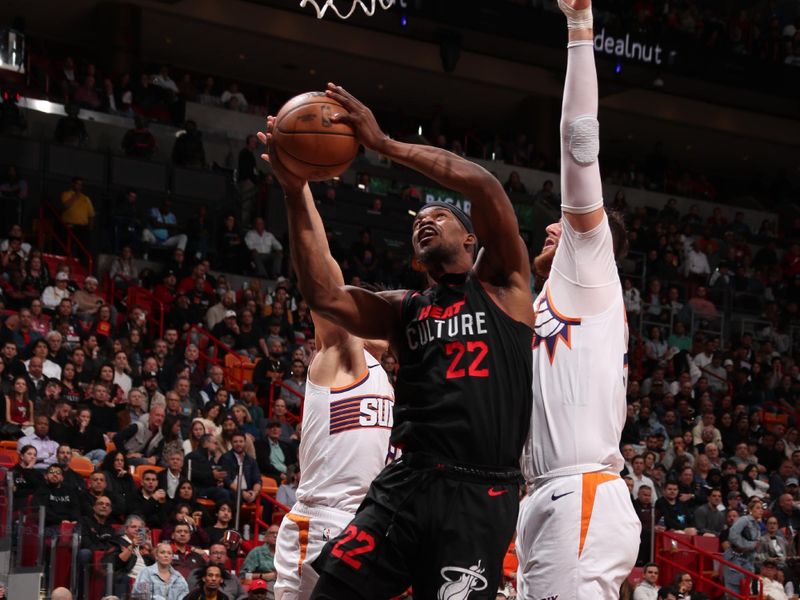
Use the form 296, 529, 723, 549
258, 124, 402, 342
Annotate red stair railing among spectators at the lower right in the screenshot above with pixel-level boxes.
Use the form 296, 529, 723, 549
655, 531, 764, 600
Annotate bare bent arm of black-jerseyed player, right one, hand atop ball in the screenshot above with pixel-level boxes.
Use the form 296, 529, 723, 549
326, 83, 530, 287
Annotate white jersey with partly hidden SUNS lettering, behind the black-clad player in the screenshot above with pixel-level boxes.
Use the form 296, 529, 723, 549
297, 351, 394, 513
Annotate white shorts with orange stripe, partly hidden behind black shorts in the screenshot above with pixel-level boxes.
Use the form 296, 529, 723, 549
275, 502, 353, 600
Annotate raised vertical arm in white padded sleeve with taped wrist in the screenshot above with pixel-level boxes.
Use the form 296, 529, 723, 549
558, 0, 604, 233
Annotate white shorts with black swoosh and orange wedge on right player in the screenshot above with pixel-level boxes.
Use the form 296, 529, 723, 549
516, 472, 641, 600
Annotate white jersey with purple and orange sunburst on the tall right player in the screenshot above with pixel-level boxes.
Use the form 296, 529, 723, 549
522, 219, 628, 482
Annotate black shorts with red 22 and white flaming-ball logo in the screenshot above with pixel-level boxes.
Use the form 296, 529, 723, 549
312, 455, 520, 600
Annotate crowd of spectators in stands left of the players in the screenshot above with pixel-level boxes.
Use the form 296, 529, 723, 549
0, 200, 412, 598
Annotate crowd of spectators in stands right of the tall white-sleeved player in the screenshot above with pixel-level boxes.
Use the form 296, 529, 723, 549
613, 194, 800, 599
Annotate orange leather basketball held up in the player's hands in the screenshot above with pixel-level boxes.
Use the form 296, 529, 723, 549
272, 92, 358, 181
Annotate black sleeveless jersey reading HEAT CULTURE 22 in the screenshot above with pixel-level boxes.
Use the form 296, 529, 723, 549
392, 273, 533, 468
